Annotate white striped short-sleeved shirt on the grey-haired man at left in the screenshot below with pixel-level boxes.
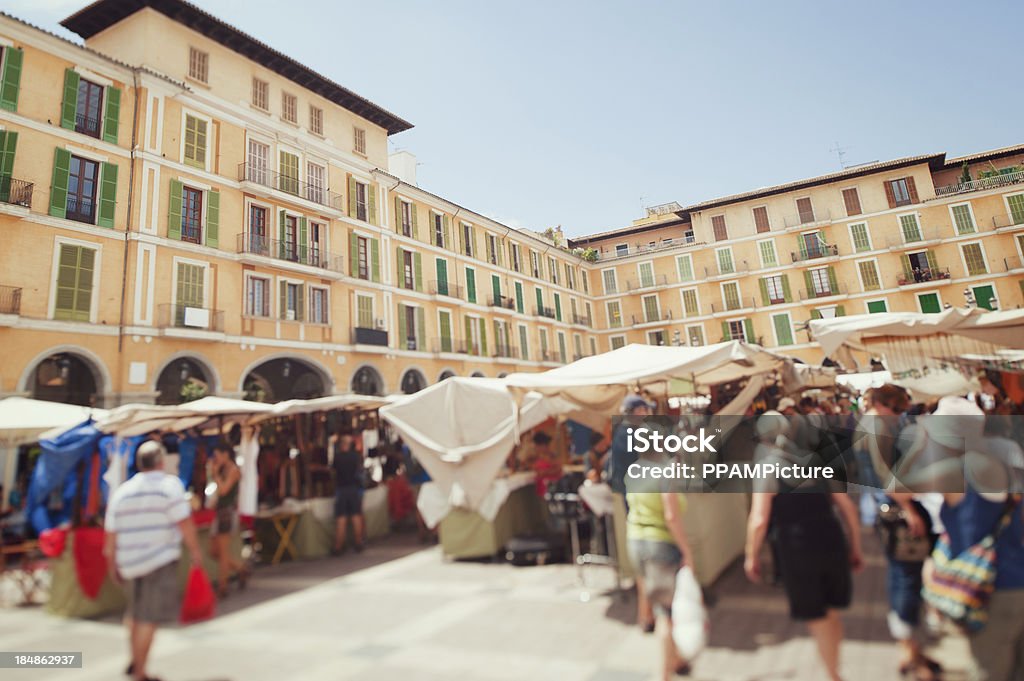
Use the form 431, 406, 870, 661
104, 470, 191, 580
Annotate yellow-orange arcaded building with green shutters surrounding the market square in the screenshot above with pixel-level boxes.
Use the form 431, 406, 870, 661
0, 0, 1024, 407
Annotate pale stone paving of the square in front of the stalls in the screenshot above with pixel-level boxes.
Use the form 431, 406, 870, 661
0, 537, 966, 681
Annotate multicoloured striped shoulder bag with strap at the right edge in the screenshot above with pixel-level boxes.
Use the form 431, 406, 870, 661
924, 497, 1019, 633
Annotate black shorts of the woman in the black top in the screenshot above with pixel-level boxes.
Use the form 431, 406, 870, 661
778, 543, 853, 620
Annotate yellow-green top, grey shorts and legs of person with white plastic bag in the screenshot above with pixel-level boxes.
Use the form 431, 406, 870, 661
626, 492, 690, 681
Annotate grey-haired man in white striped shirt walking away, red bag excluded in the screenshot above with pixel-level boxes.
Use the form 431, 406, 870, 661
103, 440, 203, 681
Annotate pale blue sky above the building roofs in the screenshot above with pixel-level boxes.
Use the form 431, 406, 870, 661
14, 0, 1024, 236
